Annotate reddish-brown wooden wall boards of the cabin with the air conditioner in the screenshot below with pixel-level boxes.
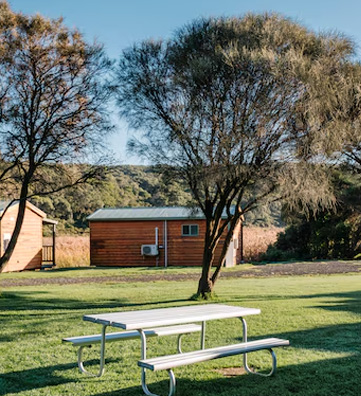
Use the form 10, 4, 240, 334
90, 220, 236, 267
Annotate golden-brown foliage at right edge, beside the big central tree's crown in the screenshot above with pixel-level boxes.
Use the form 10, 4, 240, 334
297, 49, 361, 172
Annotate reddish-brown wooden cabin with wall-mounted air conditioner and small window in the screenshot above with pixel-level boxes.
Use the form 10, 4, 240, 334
88, 207, 242, 267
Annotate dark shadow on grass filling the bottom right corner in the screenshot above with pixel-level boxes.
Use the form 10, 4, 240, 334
85, 356, 361, 396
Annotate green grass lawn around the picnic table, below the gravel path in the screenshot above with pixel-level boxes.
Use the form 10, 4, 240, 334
0, 271, 361, 396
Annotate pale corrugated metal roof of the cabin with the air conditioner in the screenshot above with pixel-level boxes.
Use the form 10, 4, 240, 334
87, 206, 208, 221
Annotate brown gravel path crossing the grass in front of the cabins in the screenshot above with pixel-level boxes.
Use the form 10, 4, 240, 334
0, 261, 361, 287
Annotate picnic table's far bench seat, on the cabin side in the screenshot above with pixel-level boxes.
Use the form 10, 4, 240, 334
62, 323, 202, 376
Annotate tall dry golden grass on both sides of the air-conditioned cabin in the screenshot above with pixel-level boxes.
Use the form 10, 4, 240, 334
48, 227, 283, 268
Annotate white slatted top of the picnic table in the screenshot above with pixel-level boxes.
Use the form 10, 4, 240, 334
83, 304, 261, 330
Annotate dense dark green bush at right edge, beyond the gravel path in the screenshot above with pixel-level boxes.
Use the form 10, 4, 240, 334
263, 168, 361, 261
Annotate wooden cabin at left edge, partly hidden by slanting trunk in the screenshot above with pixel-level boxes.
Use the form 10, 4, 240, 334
0, 201, 57, 272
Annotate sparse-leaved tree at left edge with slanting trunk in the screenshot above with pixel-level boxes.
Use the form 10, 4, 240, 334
0, 1, 111, 270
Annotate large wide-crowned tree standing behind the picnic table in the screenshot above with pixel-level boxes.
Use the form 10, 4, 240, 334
117, 14, 352, 297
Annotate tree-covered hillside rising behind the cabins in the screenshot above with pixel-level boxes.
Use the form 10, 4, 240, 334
2, 165, 280, 234
